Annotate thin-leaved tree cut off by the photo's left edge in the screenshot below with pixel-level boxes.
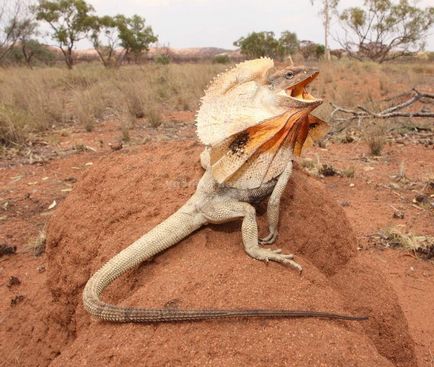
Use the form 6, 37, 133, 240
0, 0, 26, 62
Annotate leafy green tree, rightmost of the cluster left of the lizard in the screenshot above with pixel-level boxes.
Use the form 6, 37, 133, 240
116, 15, 158, 62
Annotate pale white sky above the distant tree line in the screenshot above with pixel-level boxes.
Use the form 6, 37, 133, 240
81, 0, 434, 50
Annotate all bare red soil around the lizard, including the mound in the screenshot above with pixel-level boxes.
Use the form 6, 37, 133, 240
0, 126, 434, 366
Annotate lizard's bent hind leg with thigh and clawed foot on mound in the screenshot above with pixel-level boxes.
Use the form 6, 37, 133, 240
201, 198, 302, 272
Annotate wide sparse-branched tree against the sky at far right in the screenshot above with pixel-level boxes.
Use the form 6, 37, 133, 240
339, 0, 434, 63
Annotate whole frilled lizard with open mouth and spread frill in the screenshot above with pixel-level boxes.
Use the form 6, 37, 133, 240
83, 58, 364, 322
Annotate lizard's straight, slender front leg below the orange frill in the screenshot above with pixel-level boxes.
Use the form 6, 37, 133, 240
259, 161, 292, 245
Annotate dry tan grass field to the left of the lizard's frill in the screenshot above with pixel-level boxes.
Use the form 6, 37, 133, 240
0, 64, 225, 146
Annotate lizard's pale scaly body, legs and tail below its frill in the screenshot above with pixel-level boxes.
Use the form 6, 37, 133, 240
83, 159, 365, 322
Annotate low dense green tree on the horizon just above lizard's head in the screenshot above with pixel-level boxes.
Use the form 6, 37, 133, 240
234, 31, 298, 59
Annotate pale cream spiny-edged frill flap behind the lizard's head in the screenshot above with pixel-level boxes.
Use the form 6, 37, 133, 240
196, 57, 274, 145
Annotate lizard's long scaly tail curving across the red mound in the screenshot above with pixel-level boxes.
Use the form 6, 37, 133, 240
83, 203, 367, 322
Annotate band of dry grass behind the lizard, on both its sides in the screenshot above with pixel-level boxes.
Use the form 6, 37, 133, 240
0, 60, 434, 147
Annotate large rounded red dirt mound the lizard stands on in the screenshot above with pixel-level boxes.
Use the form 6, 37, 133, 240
43, 142, 416, 366
